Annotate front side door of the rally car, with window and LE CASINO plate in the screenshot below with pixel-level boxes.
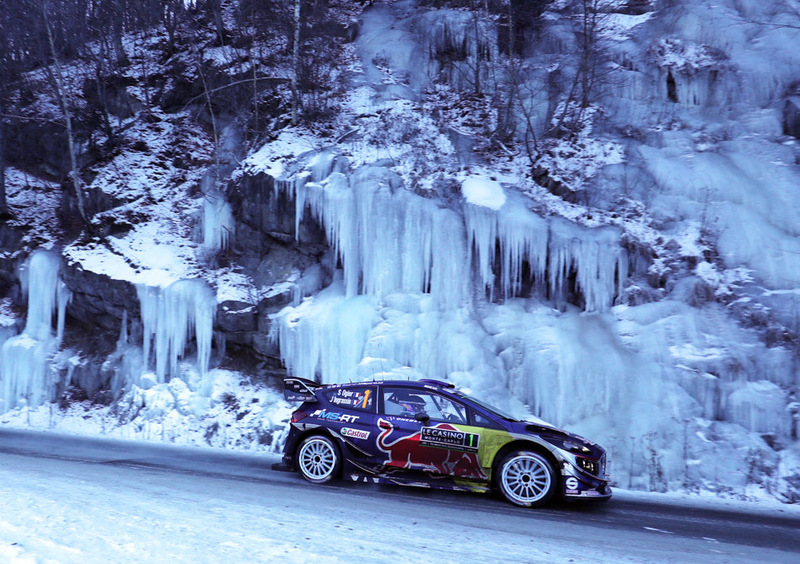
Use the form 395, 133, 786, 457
376, 385, 486, 479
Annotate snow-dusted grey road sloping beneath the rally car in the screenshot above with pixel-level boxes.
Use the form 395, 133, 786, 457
0, 430, 800, 563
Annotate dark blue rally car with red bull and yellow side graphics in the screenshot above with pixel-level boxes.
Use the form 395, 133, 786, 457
283, 378, 611, 507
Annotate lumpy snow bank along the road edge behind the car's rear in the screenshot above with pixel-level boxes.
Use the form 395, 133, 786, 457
0, 369, 292, 452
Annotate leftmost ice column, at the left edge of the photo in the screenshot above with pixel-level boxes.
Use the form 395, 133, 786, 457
0, 251, 70, 412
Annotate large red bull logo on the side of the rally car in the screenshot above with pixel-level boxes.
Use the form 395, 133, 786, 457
377, 418, 488, 480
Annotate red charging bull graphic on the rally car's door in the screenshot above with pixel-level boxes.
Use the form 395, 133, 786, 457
377, 418, 488, 480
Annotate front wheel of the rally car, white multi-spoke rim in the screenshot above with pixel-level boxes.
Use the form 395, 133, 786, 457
497, 451, 558, 507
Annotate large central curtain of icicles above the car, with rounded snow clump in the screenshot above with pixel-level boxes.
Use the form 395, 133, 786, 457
273, 153, 627, 397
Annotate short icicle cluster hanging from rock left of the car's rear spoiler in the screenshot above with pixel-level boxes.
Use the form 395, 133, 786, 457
136, 279, 217, 383
